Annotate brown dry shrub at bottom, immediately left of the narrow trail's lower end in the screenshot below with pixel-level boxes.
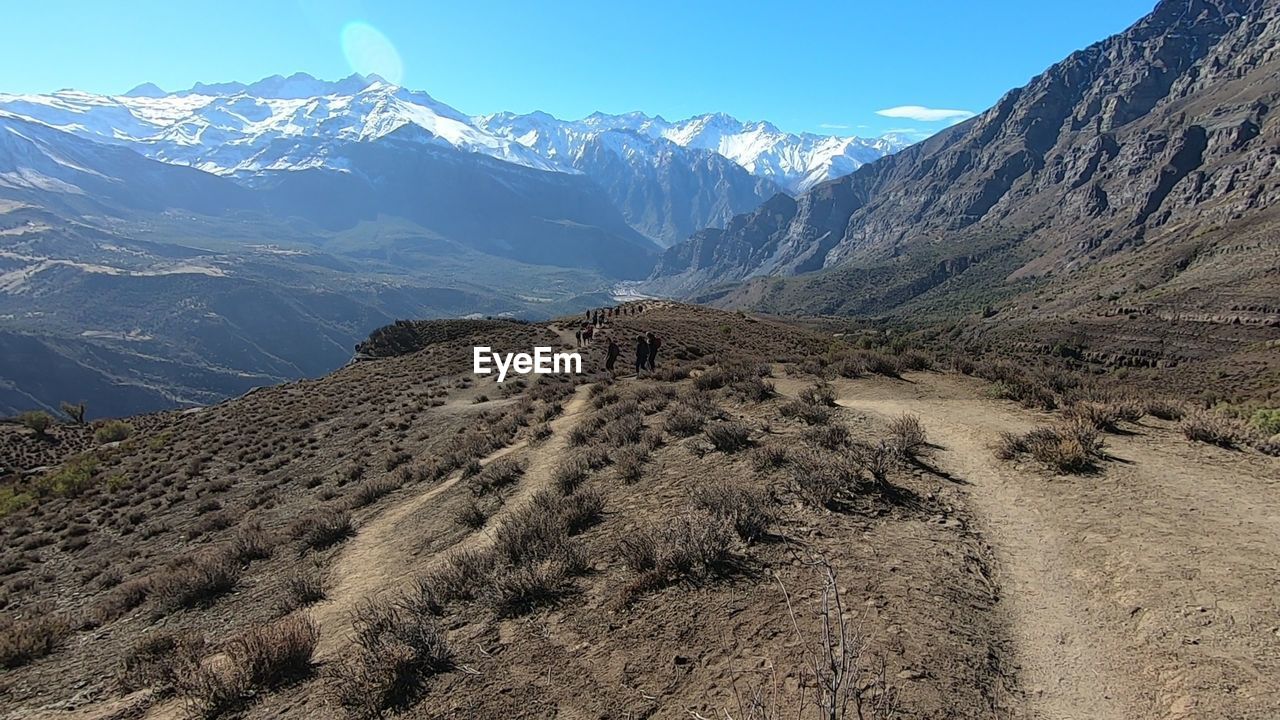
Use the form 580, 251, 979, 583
179, 615, 320, 717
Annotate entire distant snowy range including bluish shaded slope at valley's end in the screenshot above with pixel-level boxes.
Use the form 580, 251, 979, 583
0, 73, 908, 246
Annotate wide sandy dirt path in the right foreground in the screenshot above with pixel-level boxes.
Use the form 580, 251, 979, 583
780, 373, 1280, 720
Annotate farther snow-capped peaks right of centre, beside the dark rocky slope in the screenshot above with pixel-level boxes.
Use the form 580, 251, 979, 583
475, 106, 910, 193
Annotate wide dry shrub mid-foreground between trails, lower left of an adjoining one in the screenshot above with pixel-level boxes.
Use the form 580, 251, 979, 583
618, 512, 735, 596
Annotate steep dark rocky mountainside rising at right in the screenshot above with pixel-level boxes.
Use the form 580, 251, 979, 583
650, 0, 1280, 325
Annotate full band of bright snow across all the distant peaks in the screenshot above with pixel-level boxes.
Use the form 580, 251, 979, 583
0, 73, 909, 193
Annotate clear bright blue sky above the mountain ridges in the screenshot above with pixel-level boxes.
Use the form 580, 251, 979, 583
0, 0, 1153, 135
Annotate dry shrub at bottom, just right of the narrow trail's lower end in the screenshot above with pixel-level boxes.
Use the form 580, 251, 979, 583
328, 600, 452, 717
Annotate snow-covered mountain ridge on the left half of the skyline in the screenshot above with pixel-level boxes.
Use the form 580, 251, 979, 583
0, 73, 562, 174
